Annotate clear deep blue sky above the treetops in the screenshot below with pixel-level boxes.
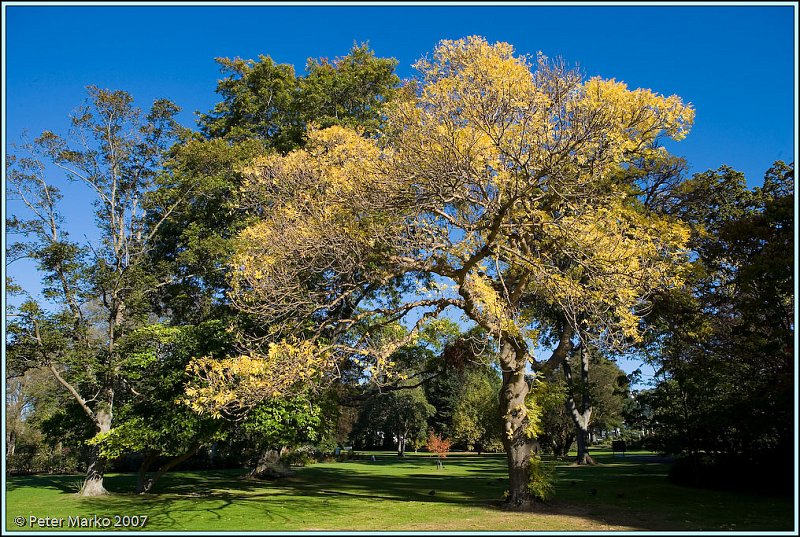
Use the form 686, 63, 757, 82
4, 4, 796, 382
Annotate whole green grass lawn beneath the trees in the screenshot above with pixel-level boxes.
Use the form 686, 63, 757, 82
6, 451, 794, 532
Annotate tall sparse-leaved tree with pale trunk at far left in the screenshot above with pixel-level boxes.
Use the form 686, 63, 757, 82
7, 86, 178, 496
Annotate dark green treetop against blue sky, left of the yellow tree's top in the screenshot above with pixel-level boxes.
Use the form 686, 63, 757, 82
200, 40, 400, 153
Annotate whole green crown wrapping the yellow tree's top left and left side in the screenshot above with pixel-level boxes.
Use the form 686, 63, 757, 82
150, 44, 399, 322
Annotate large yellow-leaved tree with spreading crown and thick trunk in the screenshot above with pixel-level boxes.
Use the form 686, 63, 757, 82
188, 38, 693, 507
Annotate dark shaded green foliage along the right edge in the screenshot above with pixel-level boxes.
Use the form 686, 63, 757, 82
642, 162, 794, 478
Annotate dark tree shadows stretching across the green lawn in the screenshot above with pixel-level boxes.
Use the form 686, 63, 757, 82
7, 455, 791, 531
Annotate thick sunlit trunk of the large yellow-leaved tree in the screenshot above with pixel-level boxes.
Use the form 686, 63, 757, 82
500, 342, 534, 510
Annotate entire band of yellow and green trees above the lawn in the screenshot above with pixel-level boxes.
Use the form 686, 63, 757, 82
5, 37, 794, 502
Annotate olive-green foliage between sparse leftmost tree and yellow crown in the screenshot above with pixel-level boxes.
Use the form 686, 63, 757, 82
148, 136, 264, 324
